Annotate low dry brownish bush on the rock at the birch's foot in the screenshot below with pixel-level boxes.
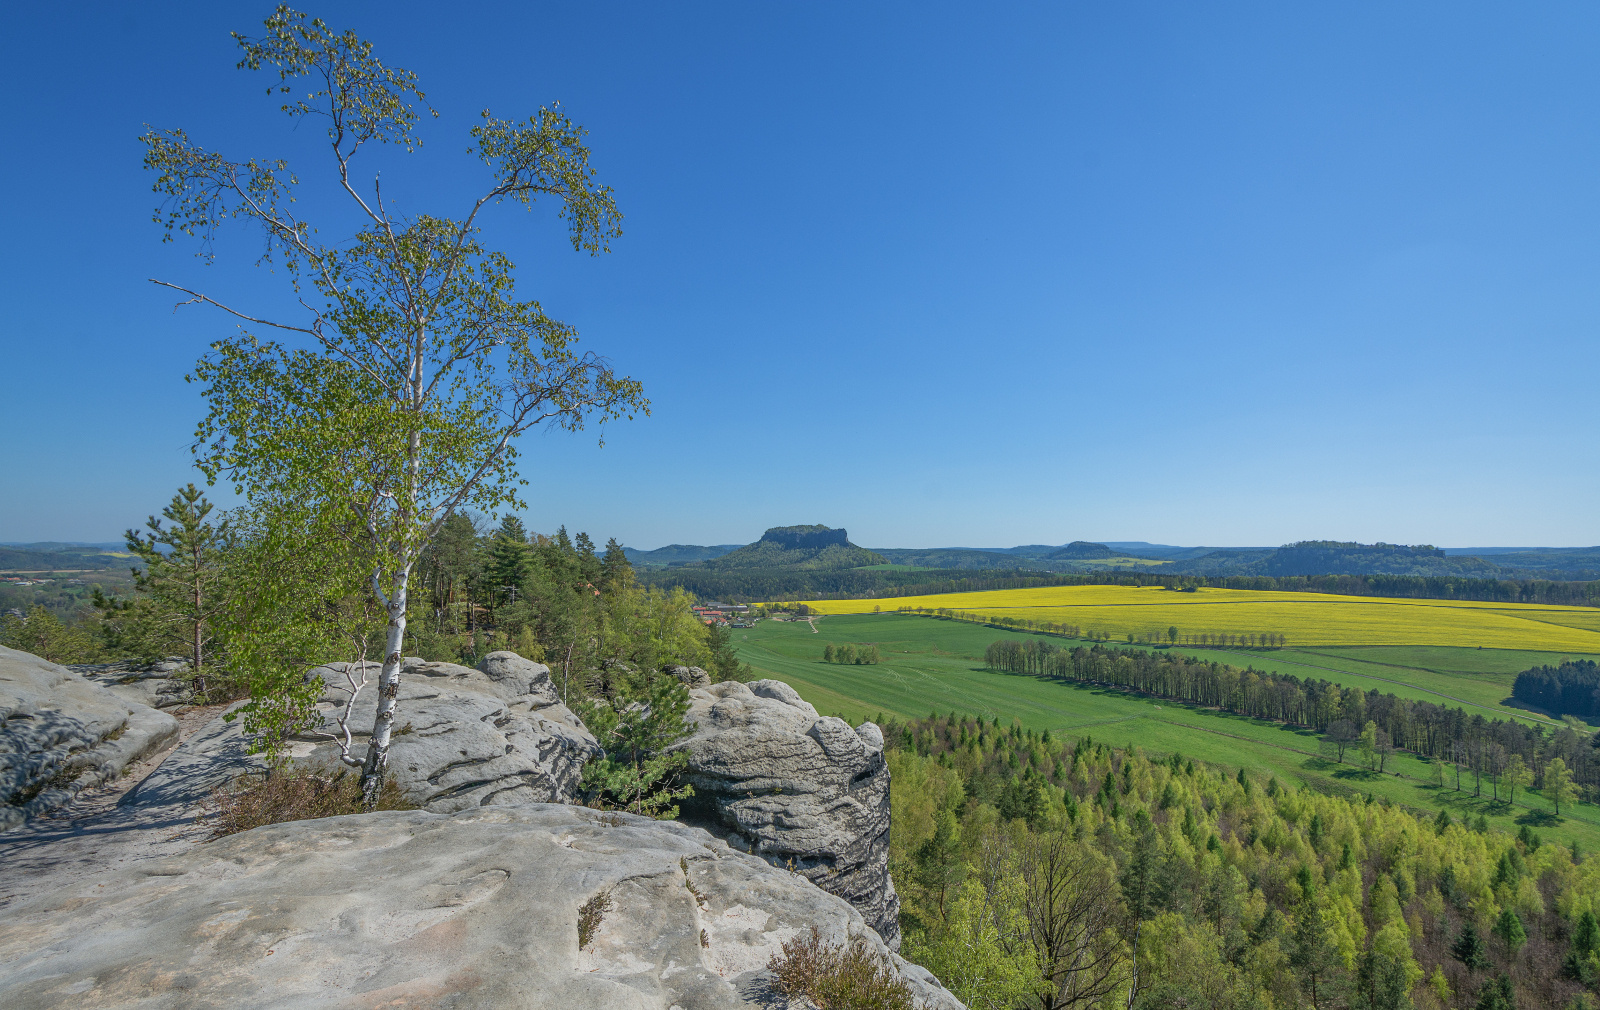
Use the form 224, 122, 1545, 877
200, 768, 416, 839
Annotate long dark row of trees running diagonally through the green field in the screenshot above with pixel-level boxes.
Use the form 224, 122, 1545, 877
984, 639, 1600, 800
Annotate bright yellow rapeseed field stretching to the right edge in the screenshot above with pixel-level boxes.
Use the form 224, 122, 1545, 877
810, 586, 1600, 653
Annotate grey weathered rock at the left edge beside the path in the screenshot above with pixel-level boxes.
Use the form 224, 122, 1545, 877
0, 647, 178, 831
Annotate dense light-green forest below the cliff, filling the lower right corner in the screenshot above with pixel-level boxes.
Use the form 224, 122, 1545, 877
885, 714, 1600, 1010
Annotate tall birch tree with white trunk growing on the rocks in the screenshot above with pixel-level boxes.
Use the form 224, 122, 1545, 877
142, 6, 650, 804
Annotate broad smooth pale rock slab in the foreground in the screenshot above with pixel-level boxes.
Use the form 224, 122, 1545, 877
0, 804, 962, 1010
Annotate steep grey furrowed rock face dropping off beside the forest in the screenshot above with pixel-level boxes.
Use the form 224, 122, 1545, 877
678, 680, 899, 951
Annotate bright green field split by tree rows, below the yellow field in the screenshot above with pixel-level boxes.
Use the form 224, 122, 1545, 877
734, 613, 1600, 848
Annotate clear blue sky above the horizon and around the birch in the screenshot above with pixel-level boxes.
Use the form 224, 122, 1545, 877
0, 2, 1600, 547
